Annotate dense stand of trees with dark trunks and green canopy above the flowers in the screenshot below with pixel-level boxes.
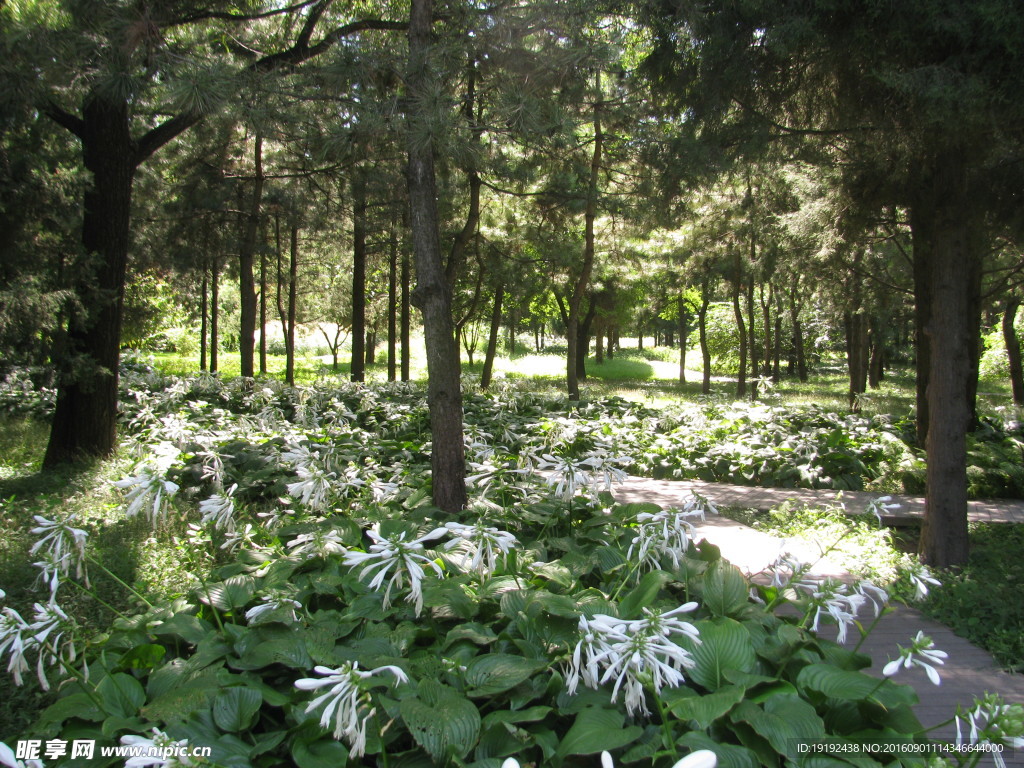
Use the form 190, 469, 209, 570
0, 0, 1024, 564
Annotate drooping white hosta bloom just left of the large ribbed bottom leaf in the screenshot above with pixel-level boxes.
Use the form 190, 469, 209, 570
295, 662, 409, 758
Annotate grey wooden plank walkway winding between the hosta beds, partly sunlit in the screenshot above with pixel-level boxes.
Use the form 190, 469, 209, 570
614, 477, 1024, 768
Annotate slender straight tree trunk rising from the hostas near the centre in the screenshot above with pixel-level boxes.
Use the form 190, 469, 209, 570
407, 0, 466, 513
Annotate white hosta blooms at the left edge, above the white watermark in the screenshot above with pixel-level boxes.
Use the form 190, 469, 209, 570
0, 595, 76, 690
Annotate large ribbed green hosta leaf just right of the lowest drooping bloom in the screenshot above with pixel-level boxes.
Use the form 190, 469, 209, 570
399, 680, 480, 762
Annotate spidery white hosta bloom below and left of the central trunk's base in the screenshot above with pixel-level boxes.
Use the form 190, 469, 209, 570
345, 526, 447, 615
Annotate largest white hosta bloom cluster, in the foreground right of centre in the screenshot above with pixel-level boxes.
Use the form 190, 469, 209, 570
565, 602, 700, 715
